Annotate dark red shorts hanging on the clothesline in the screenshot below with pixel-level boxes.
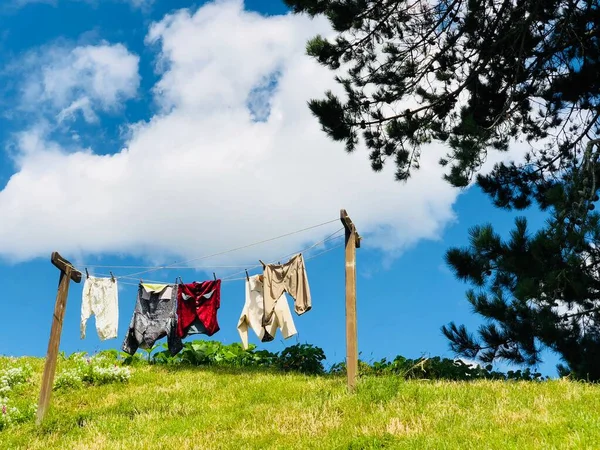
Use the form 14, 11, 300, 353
177, 280, 221, 338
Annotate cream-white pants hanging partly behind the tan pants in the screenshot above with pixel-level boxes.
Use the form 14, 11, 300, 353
237, 275, 297, 349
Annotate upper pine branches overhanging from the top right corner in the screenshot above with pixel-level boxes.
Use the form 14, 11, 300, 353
285, 0, 600, 209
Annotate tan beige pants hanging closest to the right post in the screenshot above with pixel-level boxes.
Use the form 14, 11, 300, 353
263, 253, 312, 327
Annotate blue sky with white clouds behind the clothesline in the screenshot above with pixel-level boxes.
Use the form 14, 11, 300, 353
0, 0, 557, 374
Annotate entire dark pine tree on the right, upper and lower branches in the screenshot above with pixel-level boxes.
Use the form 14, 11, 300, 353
285, 0, 600, 380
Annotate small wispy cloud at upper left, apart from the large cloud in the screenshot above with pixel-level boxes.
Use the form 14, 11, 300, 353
19, 43, 140, 122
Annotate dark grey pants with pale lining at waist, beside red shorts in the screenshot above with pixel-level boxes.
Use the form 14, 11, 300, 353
122, 283, 183, 355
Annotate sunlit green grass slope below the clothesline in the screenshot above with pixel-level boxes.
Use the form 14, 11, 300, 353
0, 358, 600, 450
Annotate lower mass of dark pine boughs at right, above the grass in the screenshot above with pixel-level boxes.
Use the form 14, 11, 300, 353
442, 144, 600, 381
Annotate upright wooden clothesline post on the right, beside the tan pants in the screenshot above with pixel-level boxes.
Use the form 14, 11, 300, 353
340, 209, 360, 391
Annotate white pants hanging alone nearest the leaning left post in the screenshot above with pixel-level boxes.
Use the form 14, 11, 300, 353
81, 277, 119, 340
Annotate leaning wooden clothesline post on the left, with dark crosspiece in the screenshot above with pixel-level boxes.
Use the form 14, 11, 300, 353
36, 252, 81, 425
